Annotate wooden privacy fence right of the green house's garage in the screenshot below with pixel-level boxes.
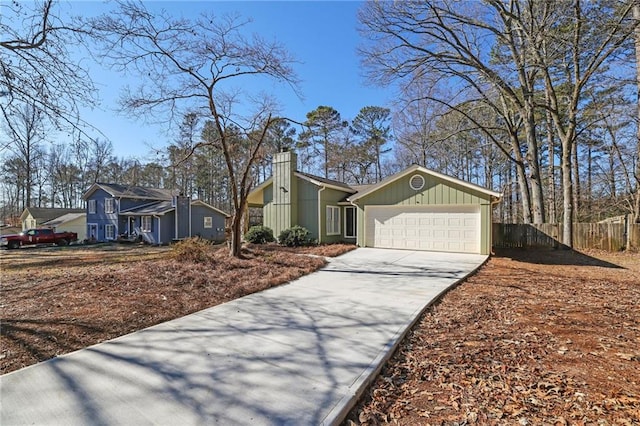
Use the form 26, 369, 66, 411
493, 223, 640, 251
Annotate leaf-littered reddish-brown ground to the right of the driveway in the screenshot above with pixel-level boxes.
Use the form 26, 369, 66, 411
344, 251, 640, 426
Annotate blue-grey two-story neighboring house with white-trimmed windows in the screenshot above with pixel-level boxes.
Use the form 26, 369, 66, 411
83, 183, 228, 244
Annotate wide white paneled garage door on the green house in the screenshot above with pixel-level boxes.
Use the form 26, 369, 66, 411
365, 206, 480, 253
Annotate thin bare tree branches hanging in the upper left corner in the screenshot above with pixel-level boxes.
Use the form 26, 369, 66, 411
0, 0, 94, 134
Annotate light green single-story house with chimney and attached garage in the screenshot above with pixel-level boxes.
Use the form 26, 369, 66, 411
248, 152, 500, 254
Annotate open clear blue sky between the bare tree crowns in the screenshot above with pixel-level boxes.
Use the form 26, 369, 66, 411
66, 0, 391, 161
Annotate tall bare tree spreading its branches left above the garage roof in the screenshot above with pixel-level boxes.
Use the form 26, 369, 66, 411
360, 0, 545, 223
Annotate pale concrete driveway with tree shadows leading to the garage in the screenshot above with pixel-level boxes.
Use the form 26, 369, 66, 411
0, 248, 486, 426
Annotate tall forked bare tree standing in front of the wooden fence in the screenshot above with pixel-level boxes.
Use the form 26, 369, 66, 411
532, 0, 637, 247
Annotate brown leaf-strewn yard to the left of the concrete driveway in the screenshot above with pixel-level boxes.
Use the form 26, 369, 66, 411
0, 241, 354, 374
